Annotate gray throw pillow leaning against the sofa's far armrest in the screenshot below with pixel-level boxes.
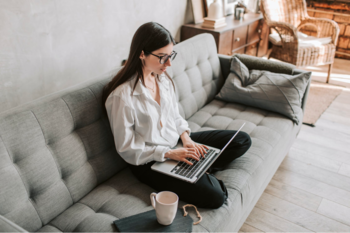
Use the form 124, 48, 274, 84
216, 57, 311, 124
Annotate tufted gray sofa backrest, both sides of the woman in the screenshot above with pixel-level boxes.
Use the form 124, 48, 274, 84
0, 34, 223, 232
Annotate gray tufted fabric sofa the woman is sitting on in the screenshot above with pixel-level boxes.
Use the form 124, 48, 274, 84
0, 34, 308, 233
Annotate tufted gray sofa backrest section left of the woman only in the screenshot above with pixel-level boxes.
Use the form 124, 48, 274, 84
0, 67, 126, 232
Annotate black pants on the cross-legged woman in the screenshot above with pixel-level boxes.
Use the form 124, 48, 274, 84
129, 130, 251, 208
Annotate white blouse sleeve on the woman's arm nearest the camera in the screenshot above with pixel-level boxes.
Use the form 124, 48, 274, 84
106, 95, 170, 165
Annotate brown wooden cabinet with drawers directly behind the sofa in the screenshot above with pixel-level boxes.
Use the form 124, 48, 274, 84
181, 13, 269, 57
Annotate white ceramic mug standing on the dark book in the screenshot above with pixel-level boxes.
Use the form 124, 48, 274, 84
151, 191, 179, 225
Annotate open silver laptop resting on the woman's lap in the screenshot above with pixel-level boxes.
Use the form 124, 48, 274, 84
151, 123, 245, 183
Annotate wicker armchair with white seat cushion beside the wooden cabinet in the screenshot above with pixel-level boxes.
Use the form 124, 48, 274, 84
260, 0, 339, 83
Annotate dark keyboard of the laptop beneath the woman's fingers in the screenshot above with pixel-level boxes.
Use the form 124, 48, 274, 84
171, 149, 215, 179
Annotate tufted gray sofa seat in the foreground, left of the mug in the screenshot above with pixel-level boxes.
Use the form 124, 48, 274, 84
37, 168, 213, 233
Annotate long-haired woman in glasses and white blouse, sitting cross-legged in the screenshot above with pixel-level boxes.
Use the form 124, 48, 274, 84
102, 22, 251, 208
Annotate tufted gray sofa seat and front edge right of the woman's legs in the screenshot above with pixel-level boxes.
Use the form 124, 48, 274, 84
188, 99, 302, 232
